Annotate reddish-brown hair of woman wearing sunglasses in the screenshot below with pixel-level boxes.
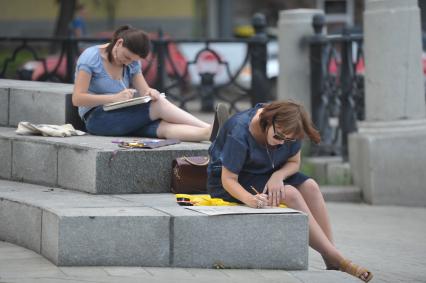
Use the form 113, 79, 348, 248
259, 100, 321, 143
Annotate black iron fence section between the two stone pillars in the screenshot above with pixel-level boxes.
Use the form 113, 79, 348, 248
305, 15, 364, 160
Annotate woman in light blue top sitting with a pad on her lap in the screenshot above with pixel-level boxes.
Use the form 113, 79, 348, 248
72, 26, 212, 141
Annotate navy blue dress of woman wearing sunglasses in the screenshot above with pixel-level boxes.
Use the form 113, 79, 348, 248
207, 104, 309, 203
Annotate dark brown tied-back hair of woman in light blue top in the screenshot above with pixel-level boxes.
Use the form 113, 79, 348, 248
106, 25, 151, 62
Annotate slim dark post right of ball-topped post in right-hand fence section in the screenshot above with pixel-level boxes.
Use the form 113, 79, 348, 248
339, 29, 356, 161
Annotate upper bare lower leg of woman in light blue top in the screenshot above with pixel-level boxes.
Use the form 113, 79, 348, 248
149, 97, 211, 129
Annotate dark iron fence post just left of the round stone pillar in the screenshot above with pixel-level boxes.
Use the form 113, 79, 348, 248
249, 13, 272, 106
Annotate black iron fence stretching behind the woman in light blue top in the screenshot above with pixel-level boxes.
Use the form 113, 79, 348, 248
0, 15, 272, 111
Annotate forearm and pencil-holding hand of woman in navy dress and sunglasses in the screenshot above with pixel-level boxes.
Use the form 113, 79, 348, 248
221, 166, 267, 208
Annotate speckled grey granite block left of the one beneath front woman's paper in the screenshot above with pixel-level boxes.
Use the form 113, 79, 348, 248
43, 207, 170, 266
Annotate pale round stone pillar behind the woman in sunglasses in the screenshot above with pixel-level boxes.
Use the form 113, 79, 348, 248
278, 9, 324, 111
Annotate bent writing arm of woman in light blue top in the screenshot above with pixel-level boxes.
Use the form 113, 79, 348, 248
72, 70, 133, 107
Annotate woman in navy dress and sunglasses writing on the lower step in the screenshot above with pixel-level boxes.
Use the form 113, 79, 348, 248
207, 101, 373, 282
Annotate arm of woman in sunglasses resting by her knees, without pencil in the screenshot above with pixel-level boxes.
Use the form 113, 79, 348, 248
263, 150, 301, 206
